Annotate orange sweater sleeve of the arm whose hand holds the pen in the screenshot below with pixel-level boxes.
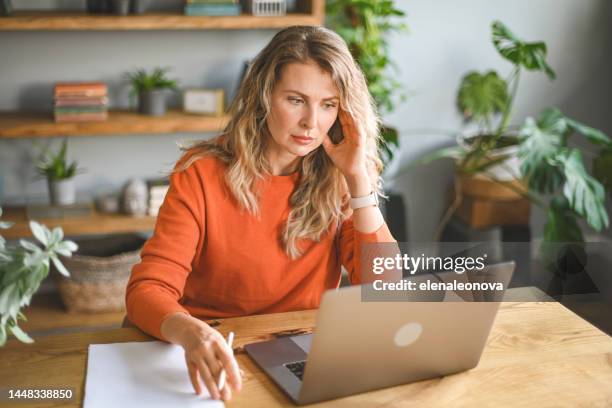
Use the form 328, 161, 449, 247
126, 166, 205, 339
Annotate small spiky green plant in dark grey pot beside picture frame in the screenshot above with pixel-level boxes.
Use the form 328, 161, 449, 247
127, 67, 178, 116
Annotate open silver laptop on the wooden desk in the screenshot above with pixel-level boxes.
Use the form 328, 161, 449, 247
245, 262, 515, 405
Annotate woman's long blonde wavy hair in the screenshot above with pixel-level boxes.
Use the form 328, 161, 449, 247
175, 26, 382, 259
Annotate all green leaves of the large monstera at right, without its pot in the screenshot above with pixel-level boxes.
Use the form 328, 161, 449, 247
418, 21, 612, 244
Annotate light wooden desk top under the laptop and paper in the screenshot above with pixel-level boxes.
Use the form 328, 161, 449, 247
0, 302, 612, 408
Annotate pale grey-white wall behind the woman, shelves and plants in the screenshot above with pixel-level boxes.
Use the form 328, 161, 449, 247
0, 0, 612, 241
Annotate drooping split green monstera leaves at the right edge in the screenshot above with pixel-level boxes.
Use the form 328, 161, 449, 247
519, 108, 612, 241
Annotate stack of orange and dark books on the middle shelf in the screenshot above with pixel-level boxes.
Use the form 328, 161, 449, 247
53, 82, 108, 122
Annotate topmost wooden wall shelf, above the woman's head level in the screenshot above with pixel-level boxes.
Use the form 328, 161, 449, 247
0, 9, 323, 31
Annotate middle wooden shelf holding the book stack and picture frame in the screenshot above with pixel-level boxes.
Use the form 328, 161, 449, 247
0, 111, 229, 138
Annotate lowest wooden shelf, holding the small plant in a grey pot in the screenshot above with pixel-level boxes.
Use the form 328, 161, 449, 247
2, 207, 157, 239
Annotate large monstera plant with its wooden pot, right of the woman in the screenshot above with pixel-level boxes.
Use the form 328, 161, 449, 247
420, 21, 612, 241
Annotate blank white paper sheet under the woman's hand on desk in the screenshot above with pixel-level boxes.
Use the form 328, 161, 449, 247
83, 341, 224, 408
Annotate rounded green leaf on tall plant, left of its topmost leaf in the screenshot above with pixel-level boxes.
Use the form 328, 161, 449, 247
457, 71, 508, 121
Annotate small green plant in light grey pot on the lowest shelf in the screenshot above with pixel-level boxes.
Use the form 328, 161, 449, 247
36, 139, 77, 205
